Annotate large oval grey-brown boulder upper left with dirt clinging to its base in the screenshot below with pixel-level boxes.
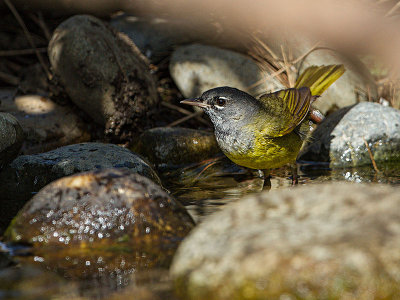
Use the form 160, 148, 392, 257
48, 15, 158, 139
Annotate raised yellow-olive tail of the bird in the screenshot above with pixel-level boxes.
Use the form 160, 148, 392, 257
294, 65, 345, 96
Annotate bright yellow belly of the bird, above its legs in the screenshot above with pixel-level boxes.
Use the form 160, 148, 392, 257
223, 132, 302, 169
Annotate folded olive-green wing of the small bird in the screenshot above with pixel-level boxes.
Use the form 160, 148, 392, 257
258, 87, 313, 137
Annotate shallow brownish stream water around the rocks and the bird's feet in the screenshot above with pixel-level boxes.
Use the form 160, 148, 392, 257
0, 159, 400, 300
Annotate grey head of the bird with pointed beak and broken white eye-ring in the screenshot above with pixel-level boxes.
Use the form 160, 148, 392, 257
181, 86, 260, 127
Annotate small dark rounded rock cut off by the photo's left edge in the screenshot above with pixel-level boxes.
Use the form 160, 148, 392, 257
0, 112, 24, 170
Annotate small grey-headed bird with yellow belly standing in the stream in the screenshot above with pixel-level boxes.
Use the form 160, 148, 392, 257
180, 65, 345, 184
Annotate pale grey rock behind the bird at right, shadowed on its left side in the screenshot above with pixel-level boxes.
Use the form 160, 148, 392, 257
298, 102, 400, 167
